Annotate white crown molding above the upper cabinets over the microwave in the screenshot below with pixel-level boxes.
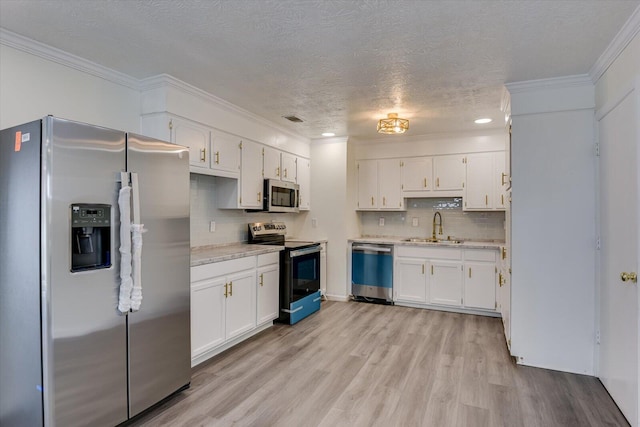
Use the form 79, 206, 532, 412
138, 74, 310, 141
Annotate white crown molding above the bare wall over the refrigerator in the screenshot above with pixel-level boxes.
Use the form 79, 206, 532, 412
0, 28, 139, 90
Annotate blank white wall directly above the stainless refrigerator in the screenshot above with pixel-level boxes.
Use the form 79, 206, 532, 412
0, 43, 140, 132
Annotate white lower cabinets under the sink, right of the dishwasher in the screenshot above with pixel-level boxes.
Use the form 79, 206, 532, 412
393, 245, 498, 315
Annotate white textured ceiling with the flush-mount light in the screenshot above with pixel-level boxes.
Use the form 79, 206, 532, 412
0, 0, 640, 139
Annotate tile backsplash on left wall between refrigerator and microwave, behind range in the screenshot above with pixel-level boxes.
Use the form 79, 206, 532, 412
191, 174, 292, 247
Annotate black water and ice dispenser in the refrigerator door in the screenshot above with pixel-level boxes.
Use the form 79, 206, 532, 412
71, 204, 111, 272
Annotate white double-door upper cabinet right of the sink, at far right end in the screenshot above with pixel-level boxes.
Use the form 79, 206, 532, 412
463, 151, 507, 211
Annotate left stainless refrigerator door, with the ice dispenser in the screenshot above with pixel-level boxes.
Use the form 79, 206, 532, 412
46, 117, 127, 426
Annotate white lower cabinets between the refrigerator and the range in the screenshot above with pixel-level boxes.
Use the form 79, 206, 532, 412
191, 252, 280, 366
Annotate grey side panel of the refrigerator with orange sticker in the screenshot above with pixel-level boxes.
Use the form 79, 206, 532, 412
0, 120, 43, 426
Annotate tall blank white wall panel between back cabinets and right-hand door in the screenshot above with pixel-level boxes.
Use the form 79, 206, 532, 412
509, 78, 596, 374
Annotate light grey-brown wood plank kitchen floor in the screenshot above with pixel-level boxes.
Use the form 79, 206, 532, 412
131, 302, 628, 427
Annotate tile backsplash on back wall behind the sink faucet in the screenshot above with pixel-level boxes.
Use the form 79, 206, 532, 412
359, 198, 505, 240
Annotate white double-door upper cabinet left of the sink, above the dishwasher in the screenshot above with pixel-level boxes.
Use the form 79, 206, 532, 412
357, 159, 404, 210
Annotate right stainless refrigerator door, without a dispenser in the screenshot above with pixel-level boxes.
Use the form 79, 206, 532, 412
127, 134, 191, 417
